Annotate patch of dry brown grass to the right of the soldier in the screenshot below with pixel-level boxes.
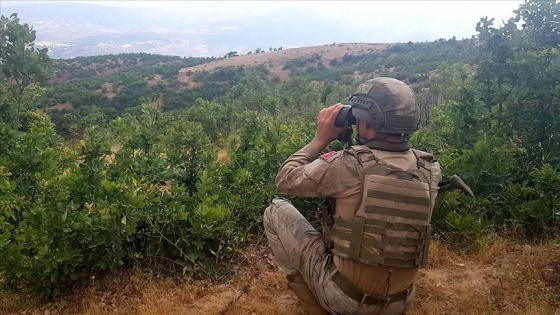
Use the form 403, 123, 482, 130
409, 239, 560, 315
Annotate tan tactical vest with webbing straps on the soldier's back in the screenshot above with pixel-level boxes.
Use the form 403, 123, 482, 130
323, 146, 436, 268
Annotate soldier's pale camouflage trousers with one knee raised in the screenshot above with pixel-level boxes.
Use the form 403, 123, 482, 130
263, 198, 416, 315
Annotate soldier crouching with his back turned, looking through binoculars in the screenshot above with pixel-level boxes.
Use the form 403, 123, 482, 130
264, 77, 441, 314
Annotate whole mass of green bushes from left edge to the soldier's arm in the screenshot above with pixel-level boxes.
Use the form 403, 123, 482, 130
0, 103, 320, 295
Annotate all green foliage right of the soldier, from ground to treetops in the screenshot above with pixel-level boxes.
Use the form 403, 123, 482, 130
406, 1, 560, 243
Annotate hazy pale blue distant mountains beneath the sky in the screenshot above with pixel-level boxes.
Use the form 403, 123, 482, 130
2, 3, 434, 58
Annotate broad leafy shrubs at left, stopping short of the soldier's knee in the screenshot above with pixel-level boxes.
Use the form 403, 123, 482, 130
0, 107, 226, 295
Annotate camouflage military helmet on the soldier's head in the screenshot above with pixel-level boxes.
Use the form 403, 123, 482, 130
350, 77, 418, 135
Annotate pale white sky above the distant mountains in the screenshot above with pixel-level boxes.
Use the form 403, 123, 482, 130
0, 0, 523, 40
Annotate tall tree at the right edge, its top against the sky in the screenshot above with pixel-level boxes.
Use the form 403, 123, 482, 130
476, 0, 560, 168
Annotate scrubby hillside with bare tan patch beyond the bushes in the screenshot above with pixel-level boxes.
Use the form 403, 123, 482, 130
40, 39, 473, 139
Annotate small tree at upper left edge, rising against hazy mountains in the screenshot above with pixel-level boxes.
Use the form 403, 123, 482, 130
0, 13, 52, 128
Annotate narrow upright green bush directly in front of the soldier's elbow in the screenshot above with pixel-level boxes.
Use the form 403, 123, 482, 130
219, 111, 316, 226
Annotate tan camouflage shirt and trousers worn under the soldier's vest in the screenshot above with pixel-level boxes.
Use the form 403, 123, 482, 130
264, 141, 441, 314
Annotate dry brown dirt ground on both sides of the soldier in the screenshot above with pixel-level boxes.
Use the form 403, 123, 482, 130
0, 240, 560, 315
